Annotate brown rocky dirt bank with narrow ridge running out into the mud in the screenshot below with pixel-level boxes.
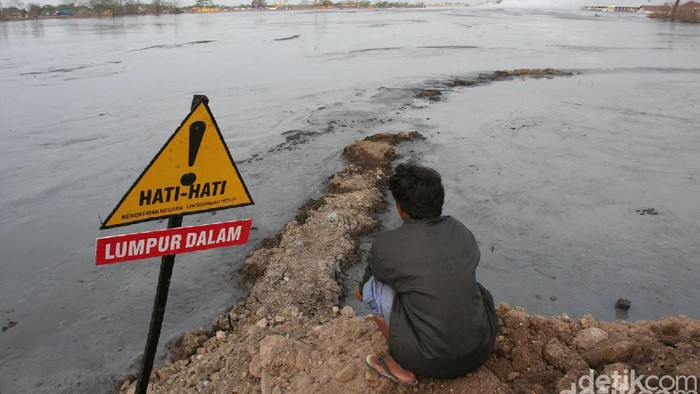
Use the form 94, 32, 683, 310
119, 132, 700, 393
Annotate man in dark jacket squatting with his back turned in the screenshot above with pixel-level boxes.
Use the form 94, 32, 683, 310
355, 164, 498, 386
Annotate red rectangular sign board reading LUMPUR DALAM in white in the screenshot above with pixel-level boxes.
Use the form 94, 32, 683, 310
95, 219, 253, 265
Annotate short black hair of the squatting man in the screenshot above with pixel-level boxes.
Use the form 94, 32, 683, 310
389, 163, 445, 219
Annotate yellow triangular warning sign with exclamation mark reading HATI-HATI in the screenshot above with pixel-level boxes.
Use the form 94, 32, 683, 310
100, 101, 253, 229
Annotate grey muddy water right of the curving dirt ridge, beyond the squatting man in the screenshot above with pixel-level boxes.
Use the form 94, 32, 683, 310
396, 70, 700, 320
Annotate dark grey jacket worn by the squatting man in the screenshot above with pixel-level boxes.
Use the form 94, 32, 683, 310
360, 216, 498, 378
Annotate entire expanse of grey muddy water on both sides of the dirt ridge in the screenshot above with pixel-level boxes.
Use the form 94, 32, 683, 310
0, 8, 700, 393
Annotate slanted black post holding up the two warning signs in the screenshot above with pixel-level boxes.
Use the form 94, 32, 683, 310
136, 215, 182, 394
